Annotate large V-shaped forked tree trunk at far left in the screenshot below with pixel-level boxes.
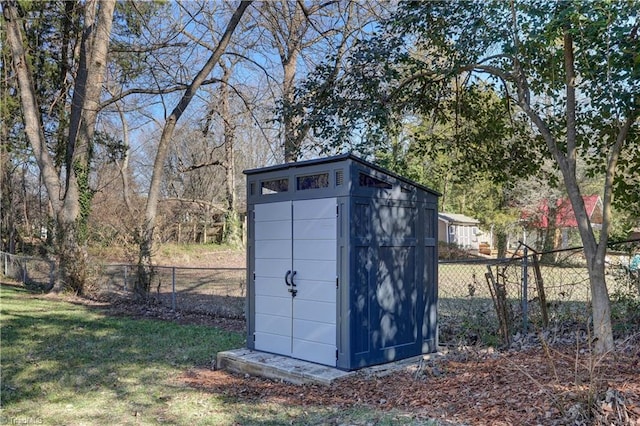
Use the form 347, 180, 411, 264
3, 0, 115, 293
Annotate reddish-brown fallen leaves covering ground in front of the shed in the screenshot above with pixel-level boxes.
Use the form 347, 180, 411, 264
181, 348, 640, 425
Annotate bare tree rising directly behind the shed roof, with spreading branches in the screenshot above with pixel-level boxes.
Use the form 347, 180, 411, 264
259, 0, 389, 162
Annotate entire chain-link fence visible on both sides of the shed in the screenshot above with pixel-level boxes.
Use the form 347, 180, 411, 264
2, 241, 640, 345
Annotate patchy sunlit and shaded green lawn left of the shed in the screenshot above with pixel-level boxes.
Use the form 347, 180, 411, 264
0, 286, 432, 426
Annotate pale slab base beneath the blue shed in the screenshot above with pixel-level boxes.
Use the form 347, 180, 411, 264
216, 349, 443, 385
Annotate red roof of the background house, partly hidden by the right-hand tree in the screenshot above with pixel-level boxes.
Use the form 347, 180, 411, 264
523, 195, 602, 229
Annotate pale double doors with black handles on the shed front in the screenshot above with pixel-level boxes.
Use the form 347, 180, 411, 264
255, 198, 337, 366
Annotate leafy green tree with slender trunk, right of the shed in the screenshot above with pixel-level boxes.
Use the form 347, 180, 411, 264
298, 0, 640, 353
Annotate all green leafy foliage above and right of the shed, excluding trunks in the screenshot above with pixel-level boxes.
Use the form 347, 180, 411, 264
298, 0, 640, 216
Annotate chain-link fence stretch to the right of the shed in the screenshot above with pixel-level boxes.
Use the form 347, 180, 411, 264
438, 241, 640, 346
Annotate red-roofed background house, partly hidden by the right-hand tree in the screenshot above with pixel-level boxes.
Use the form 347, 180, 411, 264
523, 195, 603, 249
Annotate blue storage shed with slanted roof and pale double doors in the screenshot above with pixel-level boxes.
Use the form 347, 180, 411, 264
245, 154, 439, 370
